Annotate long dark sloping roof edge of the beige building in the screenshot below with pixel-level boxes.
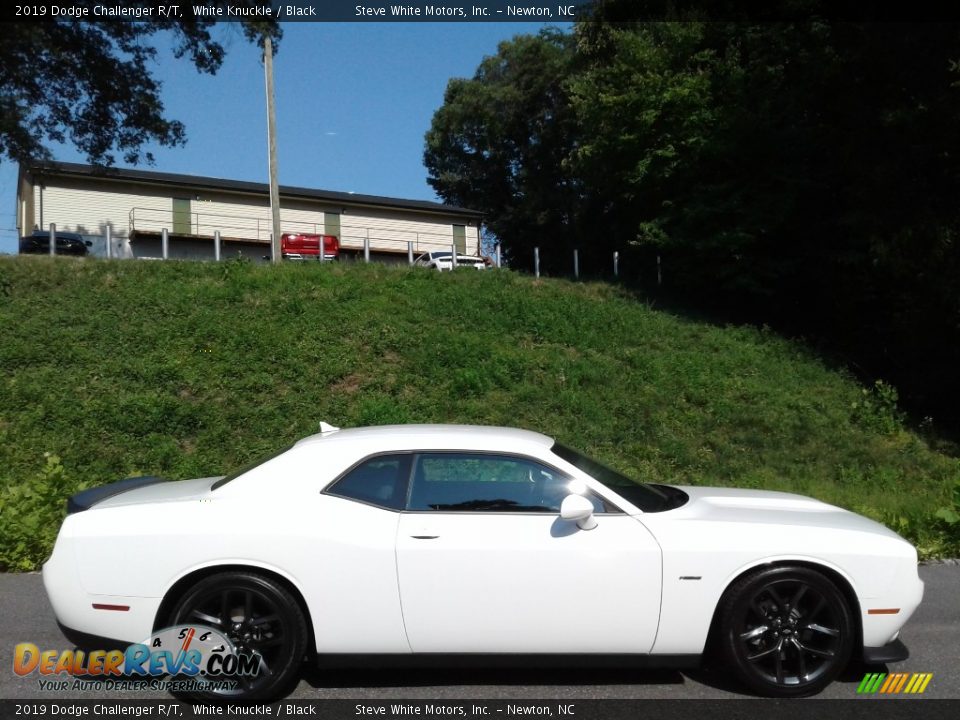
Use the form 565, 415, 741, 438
23, 162, 483, 220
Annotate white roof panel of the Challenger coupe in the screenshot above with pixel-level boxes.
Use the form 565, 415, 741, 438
297, 425, 554, 450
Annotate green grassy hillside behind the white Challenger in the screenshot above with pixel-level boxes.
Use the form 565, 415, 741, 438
0, 257, 960, 569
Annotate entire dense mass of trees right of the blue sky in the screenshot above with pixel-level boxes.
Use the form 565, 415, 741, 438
426, 2, 960, 422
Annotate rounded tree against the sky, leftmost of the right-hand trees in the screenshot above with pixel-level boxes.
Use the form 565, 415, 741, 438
424, 29, 578, 268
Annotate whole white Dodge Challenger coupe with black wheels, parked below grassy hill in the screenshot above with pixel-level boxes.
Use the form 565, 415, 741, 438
43, 424, 923, 699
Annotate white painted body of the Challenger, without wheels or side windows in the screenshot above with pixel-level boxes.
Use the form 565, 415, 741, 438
43, 426, 923, 696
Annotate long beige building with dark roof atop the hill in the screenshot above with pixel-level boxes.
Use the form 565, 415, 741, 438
17, 163, 482, 262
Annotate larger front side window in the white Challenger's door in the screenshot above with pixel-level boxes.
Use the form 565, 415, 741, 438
407, 453, 604, 513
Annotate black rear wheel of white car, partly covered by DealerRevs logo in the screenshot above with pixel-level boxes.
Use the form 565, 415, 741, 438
168, 572, 309, 701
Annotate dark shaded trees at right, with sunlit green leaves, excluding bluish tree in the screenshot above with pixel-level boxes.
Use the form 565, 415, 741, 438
569, 9, 960, 420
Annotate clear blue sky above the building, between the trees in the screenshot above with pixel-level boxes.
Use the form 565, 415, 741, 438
0, 22, 564, 253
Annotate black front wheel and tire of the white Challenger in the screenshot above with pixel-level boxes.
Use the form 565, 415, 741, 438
719, 567, 856, 697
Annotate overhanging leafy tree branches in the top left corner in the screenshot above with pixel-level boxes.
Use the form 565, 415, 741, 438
0, 0, 281, 165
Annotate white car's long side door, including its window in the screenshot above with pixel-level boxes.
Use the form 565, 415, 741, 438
397, 452, 661, 653
